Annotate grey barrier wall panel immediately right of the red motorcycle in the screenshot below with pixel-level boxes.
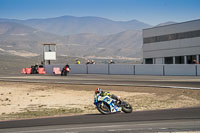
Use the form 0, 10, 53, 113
69, 64, 87, 74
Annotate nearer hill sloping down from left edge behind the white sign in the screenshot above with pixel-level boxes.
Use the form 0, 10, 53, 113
0, 22, 62, 53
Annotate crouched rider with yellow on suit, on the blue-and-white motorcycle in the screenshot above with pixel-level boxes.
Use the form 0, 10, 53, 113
95, 88, 121, 103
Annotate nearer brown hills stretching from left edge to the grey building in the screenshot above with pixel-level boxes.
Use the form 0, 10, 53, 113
0, 22, 142, 57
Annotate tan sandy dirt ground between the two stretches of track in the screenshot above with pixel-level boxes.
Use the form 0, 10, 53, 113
0, 82, 200, 120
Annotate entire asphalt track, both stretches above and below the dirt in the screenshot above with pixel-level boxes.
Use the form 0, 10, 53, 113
0, 75, 200, 133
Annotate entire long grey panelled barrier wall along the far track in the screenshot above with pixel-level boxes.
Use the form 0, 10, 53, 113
45, 64, 200, 76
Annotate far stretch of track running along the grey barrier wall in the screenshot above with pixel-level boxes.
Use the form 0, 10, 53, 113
0, 75, 200, 89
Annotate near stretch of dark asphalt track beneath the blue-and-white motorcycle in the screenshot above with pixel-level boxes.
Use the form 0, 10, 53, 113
0, 108, 200, 133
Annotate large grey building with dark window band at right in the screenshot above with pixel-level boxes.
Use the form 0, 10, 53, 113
143, 19, 200, 64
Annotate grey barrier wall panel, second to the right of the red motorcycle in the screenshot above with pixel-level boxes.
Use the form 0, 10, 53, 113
87, 64, 108, 74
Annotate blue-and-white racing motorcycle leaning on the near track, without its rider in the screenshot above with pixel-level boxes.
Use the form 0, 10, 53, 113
94, 94, 133, 114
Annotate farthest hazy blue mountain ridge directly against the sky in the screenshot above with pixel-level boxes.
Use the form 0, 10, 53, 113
0, 16, 151, 36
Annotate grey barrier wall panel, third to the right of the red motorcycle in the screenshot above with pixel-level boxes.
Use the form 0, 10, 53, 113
109, 64, 134, 75
